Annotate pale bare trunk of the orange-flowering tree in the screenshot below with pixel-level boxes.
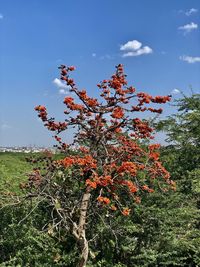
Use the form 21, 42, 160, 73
73, 188, 90, 267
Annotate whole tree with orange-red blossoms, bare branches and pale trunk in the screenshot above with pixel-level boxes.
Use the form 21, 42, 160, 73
29, 64, 175, 266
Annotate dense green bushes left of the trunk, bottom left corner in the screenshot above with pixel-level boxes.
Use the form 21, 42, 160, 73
0, 203, 81, 267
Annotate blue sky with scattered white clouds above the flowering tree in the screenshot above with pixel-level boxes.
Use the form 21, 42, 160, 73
0, 0, 200, 146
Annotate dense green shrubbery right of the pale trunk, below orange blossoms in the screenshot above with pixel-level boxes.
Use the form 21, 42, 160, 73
86, 192, 200, 267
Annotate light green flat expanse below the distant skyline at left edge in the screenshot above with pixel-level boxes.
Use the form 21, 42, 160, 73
0, 152, 32, 193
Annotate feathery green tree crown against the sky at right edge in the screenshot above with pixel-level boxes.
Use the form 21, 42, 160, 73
157, 94, 200, 187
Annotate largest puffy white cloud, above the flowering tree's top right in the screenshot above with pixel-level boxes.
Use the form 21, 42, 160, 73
120, 40, 153, 57
